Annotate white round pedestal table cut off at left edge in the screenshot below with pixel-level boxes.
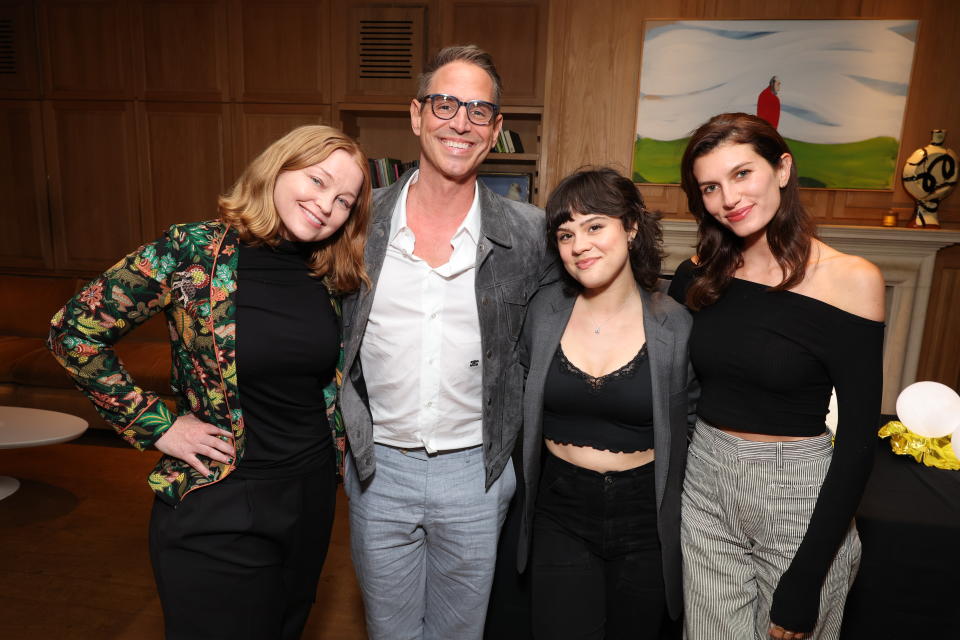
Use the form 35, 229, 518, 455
0, 406, 87, 500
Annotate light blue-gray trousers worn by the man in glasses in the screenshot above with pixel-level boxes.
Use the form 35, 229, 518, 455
344, 444, 516, 640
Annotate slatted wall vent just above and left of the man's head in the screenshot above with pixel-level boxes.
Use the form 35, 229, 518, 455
359, 20, 415, 79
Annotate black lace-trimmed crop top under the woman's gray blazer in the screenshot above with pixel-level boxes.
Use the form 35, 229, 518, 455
543, 345, 653, 453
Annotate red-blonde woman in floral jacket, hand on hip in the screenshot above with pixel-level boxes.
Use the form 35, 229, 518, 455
48, 126, 370, 639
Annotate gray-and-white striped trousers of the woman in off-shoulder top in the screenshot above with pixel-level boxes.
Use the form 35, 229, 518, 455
680, 419, 860, 640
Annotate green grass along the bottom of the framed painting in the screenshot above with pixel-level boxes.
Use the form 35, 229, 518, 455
633, 137, 897, 189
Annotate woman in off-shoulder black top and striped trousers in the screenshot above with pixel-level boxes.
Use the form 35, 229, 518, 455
670, 113, 884, 640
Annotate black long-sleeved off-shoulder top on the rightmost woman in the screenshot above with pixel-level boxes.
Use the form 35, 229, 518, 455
670, 260, 884, 631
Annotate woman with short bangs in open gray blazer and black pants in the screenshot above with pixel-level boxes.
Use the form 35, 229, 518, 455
518, 169, 695, 640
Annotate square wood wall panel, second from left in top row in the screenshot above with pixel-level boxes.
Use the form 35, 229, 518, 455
40, 0, 133, 100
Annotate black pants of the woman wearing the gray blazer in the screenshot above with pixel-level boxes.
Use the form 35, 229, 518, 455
531, 453, 675, 640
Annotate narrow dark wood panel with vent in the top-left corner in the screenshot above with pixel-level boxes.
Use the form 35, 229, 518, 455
0, 2, 40, 98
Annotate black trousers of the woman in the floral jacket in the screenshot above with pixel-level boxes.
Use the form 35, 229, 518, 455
150, 456, 336, 640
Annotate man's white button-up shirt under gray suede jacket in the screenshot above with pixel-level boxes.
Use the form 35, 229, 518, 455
360, 174, 483, 453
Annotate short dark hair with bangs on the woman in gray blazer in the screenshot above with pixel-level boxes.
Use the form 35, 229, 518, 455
547, 167, 663, 291
